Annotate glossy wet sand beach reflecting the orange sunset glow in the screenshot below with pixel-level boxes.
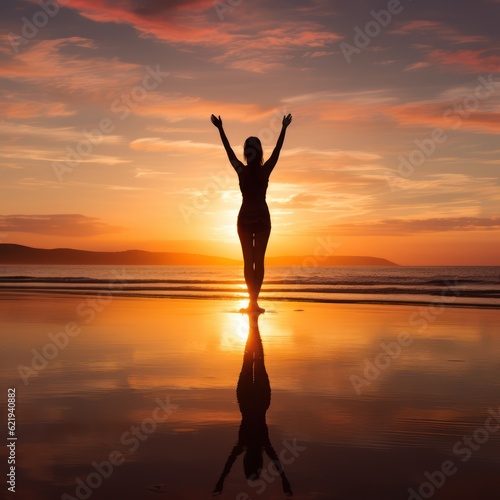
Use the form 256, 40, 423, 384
0, 293, 500, 500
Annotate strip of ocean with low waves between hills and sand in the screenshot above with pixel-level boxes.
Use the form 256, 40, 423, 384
0, 266, 500, 309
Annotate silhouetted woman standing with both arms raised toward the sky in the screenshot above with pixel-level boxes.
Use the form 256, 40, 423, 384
211, 114, 292, 312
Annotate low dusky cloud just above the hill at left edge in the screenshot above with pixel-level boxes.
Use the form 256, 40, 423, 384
0, 214, 124, 238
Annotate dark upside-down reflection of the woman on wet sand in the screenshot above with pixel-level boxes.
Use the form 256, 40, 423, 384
212, 318, 293, 496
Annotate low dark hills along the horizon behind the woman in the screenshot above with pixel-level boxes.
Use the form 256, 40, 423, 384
0, 243, 397, 266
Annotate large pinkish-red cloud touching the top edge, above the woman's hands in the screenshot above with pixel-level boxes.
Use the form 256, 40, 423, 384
58, 0, 340, 73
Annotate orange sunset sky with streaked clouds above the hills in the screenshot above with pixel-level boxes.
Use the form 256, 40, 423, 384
0, 0, 500, 265
